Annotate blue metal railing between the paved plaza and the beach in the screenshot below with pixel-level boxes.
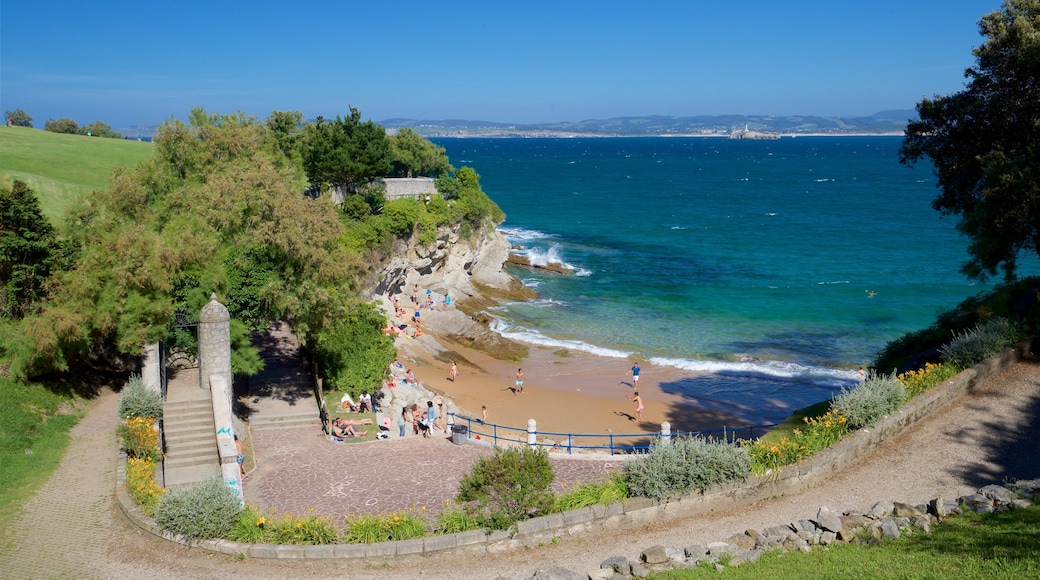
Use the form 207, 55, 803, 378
448, 413, 777, 455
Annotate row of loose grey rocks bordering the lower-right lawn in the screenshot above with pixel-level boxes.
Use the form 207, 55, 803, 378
528, 479, 1040, 579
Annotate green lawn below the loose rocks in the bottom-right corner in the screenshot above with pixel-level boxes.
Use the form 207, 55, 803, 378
651, 505, 1040, 580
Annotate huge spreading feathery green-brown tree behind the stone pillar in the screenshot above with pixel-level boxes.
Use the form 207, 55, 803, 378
0, 113, 389, 375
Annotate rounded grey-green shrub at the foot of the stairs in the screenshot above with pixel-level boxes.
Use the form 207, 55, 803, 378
155, 478, 242, 542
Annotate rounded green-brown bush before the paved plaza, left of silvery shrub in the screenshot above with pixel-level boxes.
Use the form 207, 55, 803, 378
458, 447, 555, 529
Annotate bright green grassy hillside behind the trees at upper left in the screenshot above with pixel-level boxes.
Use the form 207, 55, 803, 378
0, 127, 152, 225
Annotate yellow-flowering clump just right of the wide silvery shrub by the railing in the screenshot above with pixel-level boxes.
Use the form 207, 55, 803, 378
743, 411, 849, 473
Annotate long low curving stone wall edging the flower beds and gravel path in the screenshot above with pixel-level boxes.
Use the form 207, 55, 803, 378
116, 341, 1032, 563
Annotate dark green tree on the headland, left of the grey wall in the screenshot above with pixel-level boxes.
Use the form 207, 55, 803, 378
304, 107, 391, 189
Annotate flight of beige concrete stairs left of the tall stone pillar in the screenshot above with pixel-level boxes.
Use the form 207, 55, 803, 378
162, 399, 220, 487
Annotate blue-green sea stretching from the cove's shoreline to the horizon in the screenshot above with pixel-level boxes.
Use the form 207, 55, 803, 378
435, 136, 989, 411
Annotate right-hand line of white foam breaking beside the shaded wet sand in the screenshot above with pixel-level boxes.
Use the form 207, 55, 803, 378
650, 357, 860, 387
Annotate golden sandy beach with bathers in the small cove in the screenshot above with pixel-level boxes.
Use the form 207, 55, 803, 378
386, 299, 777, 444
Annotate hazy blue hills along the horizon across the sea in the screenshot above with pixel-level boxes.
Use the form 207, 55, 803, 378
381, 110, 917, 137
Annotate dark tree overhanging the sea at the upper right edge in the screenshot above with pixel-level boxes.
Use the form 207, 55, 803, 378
900, 0, 1040, 280
